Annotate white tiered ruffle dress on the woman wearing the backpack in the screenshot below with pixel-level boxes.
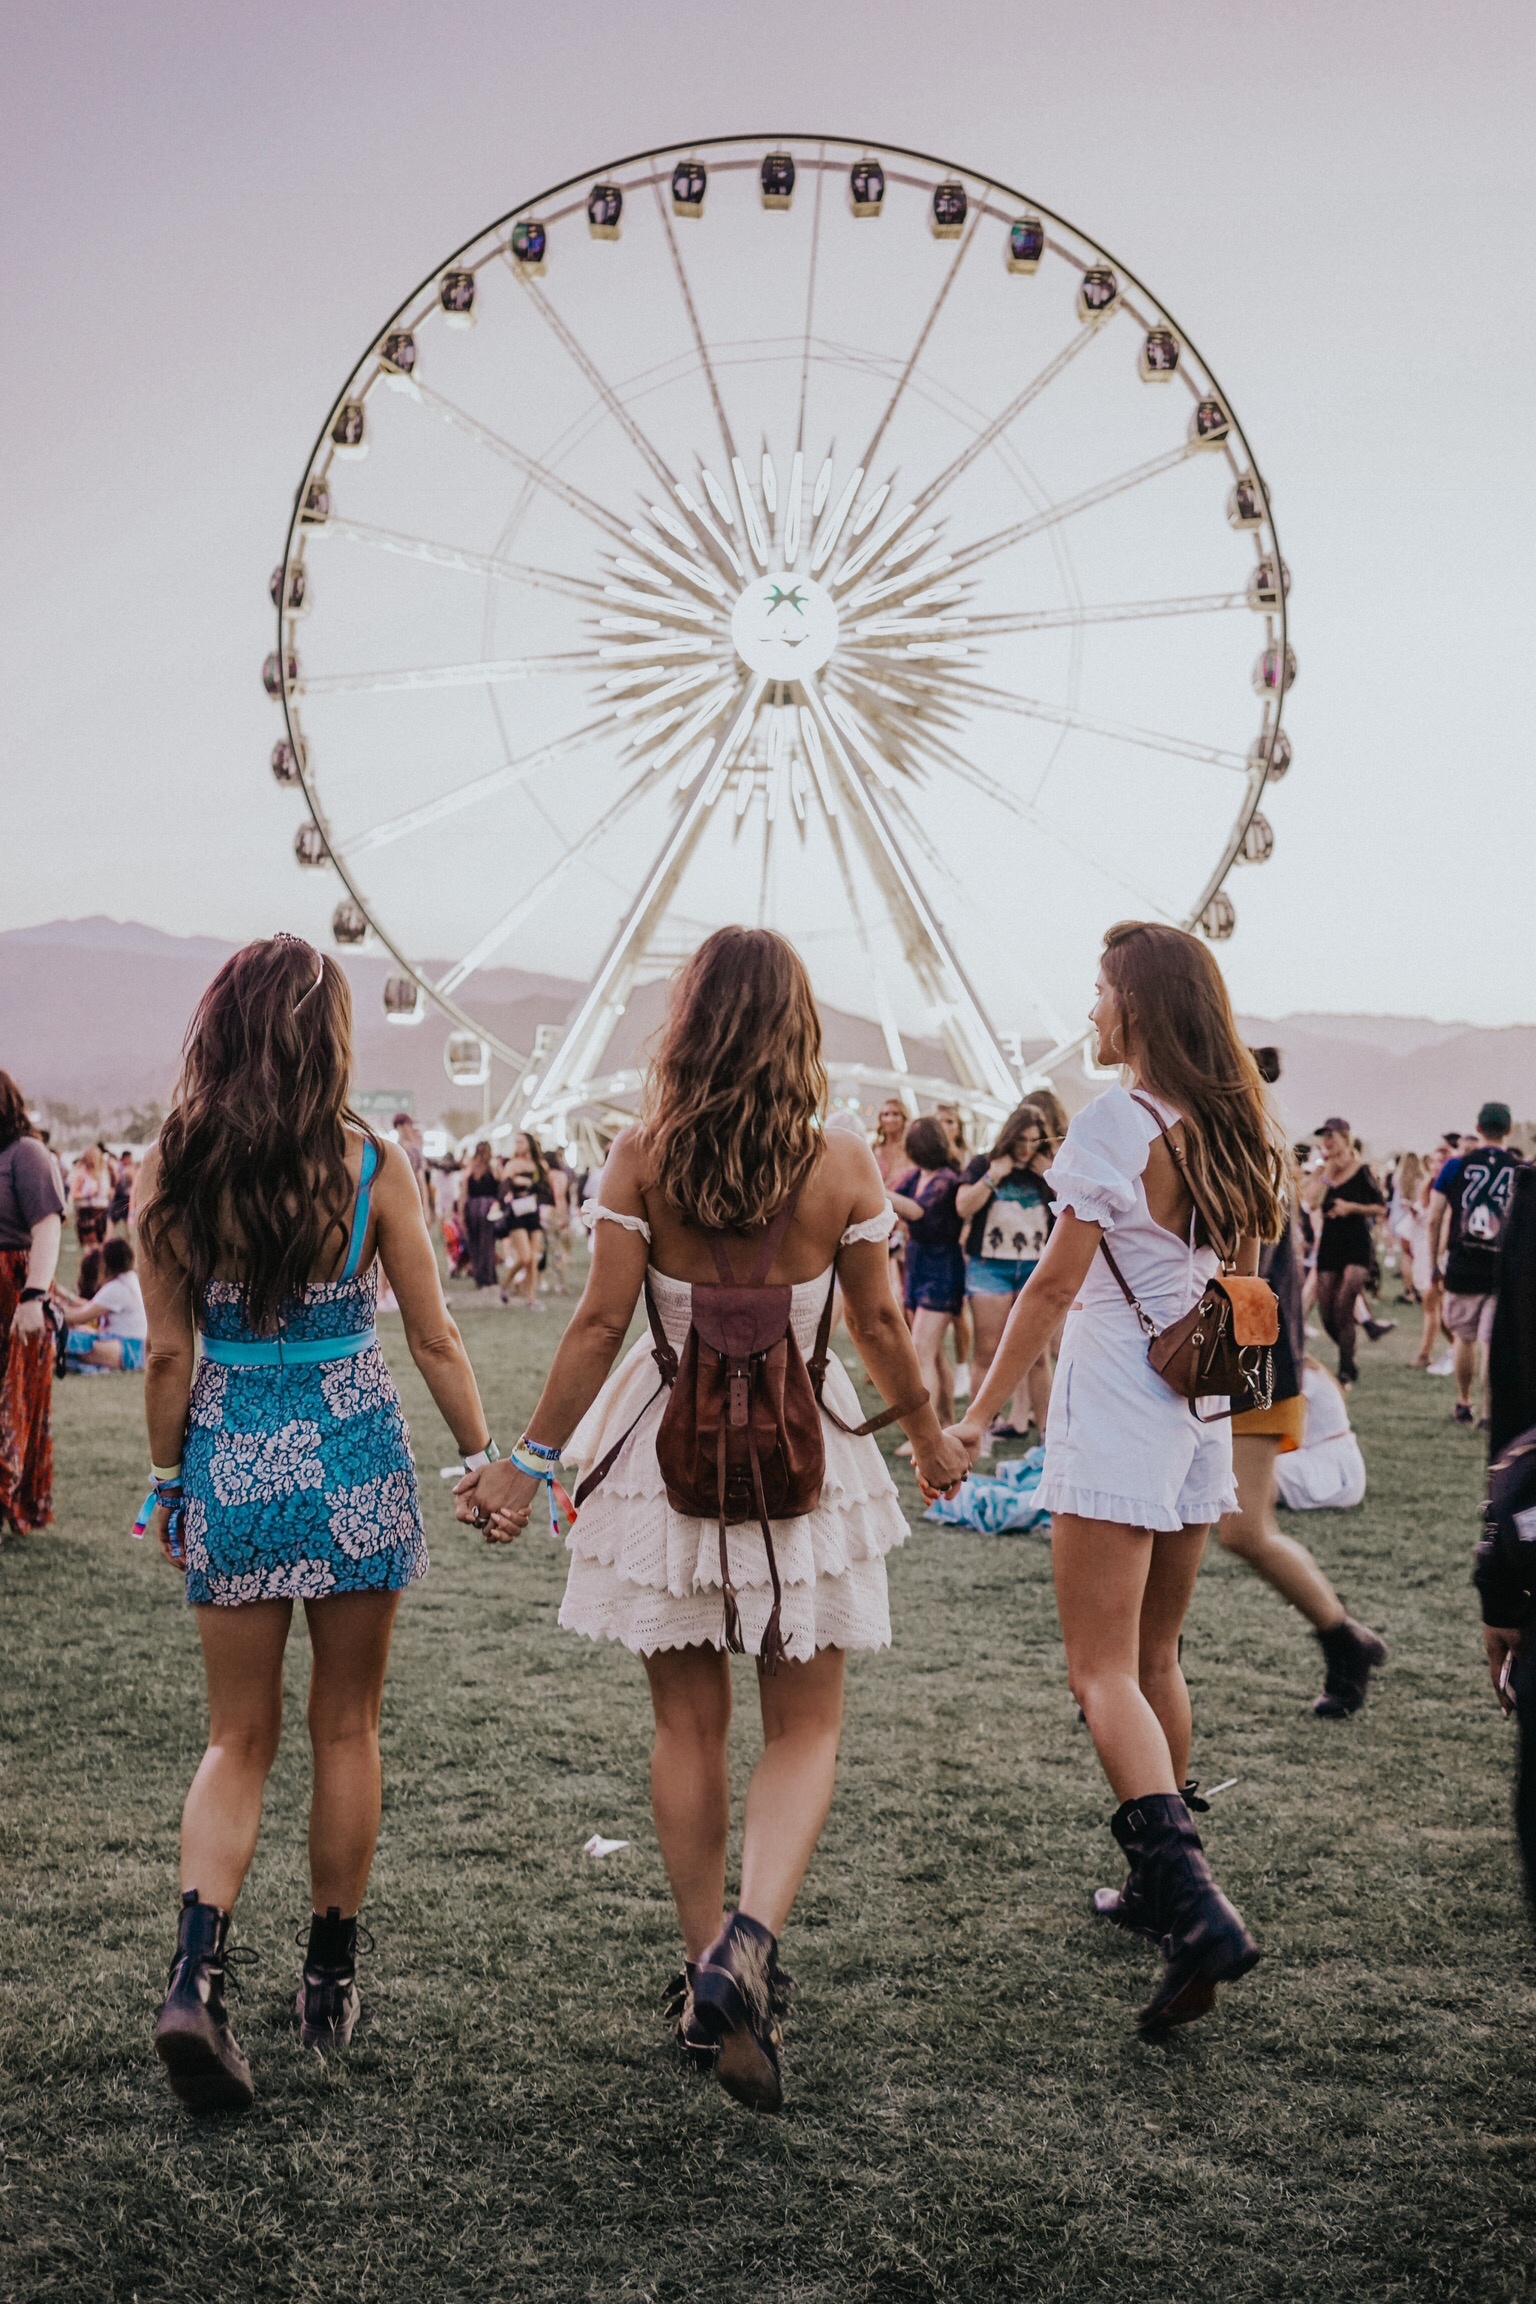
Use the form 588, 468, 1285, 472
560, 1207, 907, 1663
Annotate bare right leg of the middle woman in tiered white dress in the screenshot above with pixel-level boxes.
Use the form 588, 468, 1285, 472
742, 1647, 845, 1935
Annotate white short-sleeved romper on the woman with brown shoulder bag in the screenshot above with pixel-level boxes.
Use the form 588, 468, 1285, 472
1039, 1087, 1237, 1530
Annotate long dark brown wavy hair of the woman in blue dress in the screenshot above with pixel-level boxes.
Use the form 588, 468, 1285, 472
138, 935, 378, 1334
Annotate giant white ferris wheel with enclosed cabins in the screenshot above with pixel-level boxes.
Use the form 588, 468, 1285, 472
265, 136, 1297, 1136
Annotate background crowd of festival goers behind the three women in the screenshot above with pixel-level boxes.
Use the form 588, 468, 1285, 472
0, 1073, 1522, 1539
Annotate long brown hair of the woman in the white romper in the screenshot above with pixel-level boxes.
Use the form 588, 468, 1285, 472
1103, 919, 1285, 1258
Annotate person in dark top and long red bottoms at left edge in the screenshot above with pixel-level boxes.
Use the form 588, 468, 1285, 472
0, 1071, 64, 1544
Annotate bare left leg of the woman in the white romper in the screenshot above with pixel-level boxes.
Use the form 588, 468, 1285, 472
1050, 1511, 1184, 1799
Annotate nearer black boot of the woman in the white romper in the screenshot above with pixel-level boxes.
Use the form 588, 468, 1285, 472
1117, 1793, 1260, 2034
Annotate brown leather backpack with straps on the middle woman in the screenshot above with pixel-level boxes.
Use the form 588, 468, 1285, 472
576, 1193, 928, 1673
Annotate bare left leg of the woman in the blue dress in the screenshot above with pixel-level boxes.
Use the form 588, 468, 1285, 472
182, 1599, 292, 1912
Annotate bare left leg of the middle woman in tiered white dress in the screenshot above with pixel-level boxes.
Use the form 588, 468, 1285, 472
640, 1647, 730, 1961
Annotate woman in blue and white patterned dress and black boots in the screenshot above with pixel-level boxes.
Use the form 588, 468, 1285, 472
138, 935, 493, 2110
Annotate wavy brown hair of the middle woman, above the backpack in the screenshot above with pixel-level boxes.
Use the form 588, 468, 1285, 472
642, 929, 827, 1233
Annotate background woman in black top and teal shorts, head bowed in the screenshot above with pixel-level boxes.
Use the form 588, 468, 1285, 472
956, 1097, 1057, 1440
